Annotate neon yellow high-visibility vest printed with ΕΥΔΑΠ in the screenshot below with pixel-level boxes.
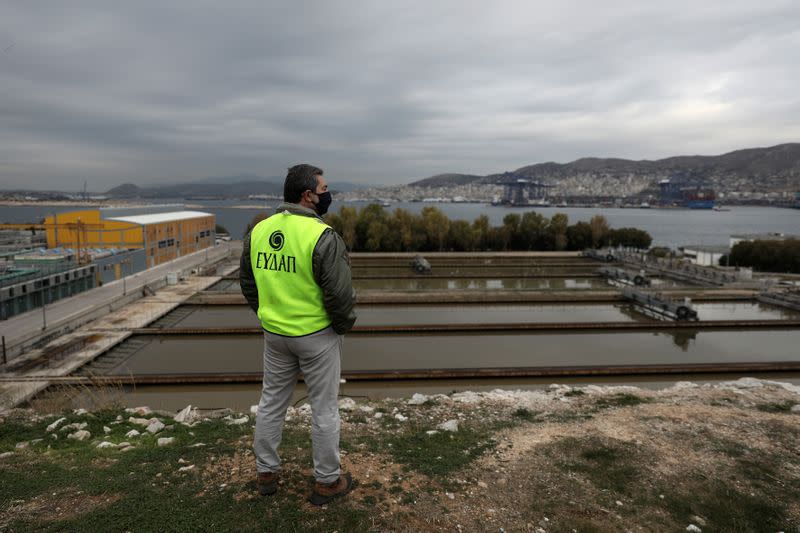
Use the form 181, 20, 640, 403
250, 211, 331, 337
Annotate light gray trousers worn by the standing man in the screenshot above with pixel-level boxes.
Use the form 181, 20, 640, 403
253, 327, 342, 483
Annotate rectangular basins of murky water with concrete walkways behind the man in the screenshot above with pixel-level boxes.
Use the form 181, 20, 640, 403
0, 250, 800, 408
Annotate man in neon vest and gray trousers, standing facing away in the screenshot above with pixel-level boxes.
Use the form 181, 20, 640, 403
239, 164, 356, 505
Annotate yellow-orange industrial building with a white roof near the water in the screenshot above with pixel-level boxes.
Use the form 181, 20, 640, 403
45, 206, 216, 267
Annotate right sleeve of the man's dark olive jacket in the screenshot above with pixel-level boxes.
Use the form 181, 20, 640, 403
312, 229, 356, 335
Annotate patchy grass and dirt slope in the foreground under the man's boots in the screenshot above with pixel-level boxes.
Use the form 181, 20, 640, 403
0, 388, 800, 531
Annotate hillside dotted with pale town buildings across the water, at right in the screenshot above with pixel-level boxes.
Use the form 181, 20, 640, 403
409, 143, 800, 195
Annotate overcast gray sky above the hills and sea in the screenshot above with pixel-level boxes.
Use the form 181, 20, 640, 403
0, 0, 800, 191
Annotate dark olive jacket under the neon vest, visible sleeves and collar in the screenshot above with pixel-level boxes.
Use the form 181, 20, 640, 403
239, 203, 356, 335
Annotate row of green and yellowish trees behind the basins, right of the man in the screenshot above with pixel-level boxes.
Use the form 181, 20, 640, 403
325, 204, 652, 252
